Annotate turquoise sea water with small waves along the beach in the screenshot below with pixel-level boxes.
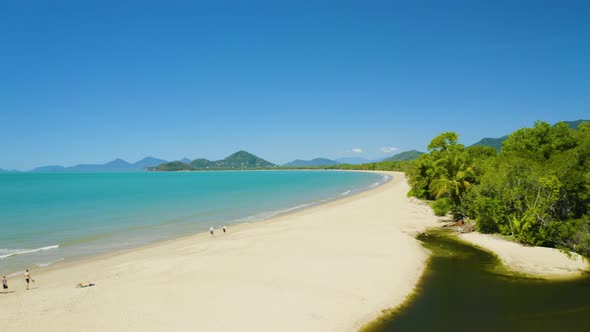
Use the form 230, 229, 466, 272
0, 171, 387, 274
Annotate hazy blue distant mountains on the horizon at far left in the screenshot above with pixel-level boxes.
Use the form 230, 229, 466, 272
32, 157, 166, 173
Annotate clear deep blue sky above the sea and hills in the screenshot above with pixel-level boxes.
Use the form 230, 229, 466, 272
0, 0, 590, 169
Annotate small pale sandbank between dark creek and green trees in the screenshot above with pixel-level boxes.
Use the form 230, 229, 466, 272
459, 232, 589, 278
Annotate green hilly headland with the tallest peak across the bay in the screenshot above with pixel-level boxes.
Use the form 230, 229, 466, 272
157, 151, 277, 172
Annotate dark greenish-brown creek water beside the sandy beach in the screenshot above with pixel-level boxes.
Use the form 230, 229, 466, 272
362, 230, 590, 332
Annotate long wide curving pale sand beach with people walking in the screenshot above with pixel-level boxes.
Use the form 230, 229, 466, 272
0, 173, 436, 332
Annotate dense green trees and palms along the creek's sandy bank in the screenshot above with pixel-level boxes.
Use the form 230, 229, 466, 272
407, 122, 590, 255
